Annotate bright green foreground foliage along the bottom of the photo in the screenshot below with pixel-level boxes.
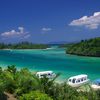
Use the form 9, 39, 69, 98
0, 66, 100, 100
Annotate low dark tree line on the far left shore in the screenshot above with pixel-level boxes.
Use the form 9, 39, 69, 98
0, 42, 48, 49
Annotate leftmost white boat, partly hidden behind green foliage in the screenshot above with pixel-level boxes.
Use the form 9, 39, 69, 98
36, 71, 56, 79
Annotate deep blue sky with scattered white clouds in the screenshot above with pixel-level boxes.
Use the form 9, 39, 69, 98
0, 0, 100, 43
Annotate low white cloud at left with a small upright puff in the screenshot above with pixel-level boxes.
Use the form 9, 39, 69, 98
1, 27, 28, 38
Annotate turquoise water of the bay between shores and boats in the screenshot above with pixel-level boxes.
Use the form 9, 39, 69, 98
0, 48, 100, 80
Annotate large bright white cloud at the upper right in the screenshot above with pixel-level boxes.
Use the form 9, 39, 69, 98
69, 12, 100, 29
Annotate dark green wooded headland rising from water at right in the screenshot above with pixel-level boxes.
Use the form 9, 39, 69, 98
66, 38, 100, 57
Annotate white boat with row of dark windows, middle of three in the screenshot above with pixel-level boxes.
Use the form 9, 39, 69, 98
67, 74, 89, 87
